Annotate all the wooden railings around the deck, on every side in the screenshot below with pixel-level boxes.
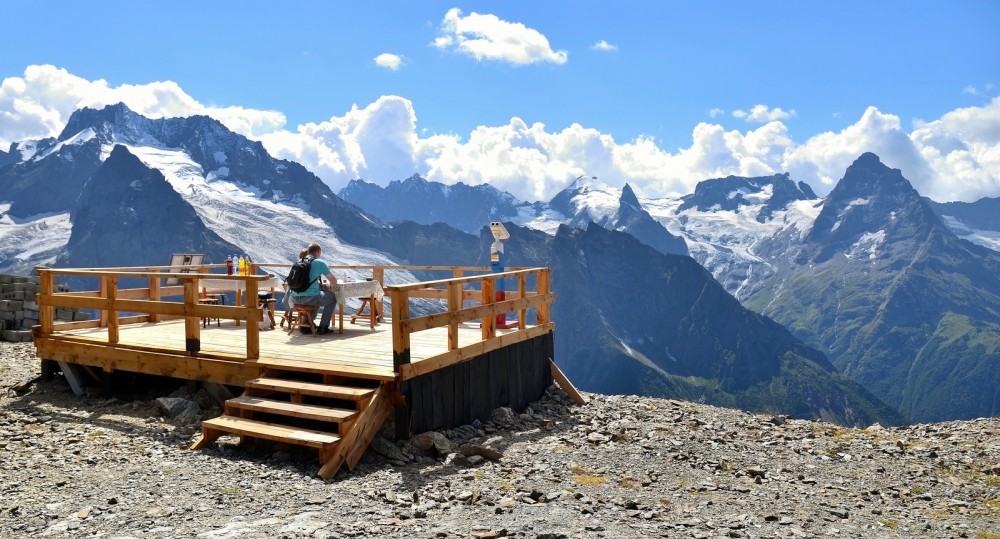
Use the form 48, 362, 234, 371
36, 263, 554, 379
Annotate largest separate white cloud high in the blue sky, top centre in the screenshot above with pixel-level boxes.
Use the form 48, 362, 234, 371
433, 8, 569, 65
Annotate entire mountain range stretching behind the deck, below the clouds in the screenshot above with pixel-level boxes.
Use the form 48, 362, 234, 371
0, 105, 1000, 424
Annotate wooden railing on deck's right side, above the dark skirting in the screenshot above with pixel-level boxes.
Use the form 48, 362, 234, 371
385, 268, 554, 379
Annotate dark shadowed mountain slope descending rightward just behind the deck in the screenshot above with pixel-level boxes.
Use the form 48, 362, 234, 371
496, 223, 903, 424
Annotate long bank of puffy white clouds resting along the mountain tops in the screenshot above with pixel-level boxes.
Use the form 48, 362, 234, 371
0, 65, 1000, 201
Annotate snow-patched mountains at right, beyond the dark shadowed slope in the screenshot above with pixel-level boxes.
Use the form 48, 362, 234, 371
344, 154, 1000, 421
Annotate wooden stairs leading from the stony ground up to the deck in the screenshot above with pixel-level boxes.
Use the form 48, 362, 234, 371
191, 368, 390, 479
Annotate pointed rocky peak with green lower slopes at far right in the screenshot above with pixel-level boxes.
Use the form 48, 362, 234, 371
747, 154, 1000, 421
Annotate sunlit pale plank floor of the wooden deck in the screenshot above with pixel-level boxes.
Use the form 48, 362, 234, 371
60, 318, 530, 380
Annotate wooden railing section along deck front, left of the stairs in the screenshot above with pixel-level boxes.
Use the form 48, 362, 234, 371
37, 264, 268, 359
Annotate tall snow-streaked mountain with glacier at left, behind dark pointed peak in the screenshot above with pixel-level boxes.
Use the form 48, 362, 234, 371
0, 104, 466, 284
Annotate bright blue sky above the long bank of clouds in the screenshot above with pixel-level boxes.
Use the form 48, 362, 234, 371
0, 1, 1000, 202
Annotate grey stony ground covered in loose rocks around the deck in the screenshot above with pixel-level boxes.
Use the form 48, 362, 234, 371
0, 343, 1000, 538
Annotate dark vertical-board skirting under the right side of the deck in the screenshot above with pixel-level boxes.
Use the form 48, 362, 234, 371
396, 333, 553, 437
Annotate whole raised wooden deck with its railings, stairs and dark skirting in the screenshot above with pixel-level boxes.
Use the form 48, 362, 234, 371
34, 265, 555, 478
